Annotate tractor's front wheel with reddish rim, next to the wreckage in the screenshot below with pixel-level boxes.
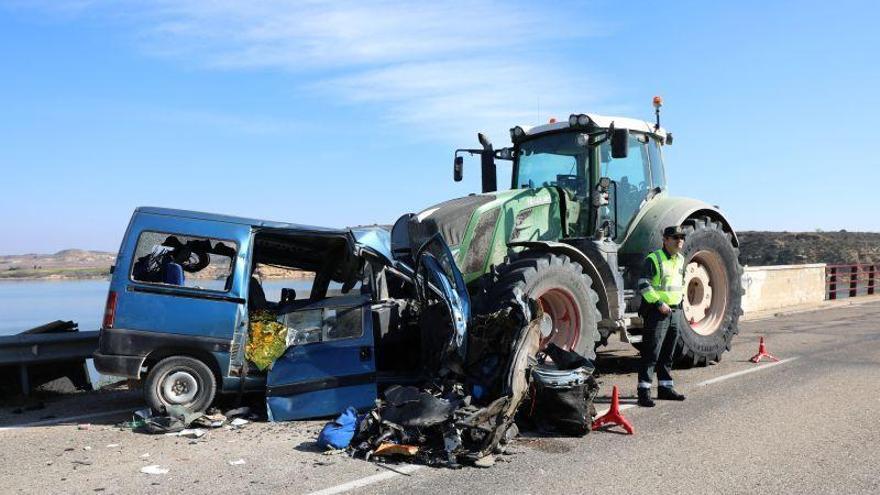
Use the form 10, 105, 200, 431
489, 252, 601, 359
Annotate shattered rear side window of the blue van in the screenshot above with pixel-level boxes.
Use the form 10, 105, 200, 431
131, 231, 236, 291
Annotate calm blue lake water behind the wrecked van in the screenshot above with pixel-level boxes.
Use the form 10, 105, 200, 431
0, 279, 312, 335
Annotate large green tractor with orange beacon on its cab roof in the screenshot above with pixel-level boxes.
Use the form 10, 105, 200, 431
391, 98, 743, 365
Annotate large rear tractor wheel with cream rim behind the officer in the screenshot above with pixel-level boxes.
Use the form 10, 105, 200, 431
676, 217, 743, 366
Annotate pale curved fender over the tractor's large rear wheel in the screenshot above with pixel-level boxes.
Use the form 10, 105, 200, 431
620, 196, 739, 266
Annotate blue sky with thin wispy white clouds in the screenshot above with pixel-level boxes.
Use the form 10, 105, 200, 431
0, 0, 880, 254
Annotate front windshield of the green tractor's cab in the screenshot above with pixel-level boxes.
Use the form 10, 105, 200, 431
514, 132, 589, 200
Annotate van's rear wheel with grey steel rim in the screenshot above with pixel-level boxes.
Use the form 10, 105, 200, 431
144, 356, 217, 413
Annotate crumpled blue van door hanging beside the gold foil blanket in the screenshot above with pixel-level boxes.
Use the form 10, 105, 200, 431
266, 294, 377, 421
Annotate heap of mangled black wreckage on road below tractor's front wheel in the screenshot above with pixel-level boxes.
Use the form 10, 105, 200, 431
351, 307, 540, 468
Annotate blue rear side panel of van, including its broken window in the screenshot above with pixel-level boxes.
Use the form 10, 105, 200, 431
106, 214, 250, 371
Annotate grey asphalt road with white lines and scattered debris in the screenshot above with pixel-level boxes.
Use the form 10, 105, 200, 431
0, 299, 880, 495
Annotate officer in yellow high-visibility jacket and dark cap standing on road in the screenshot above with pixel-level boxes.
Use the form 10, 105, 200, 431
638, 226, 685, 407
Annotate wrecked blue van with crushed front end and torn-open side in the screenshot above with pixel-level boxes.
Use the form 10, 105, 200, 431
94, 207, 470, 420
